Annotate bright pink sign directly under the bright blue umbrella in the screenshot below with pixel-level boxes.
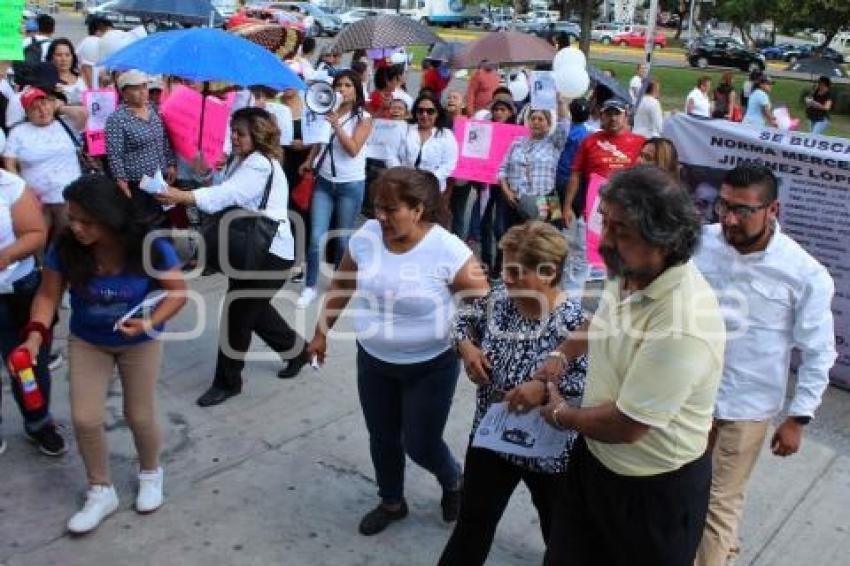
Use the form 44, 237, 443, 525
160, 86, 233, 166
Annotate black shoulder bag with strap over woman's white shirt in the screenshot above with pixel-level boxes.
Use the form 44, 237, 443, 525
202, 157, 278, 279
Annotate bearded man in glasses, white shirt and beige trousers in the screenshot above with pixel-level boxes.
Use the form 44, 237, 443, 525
694, 164, 836, 566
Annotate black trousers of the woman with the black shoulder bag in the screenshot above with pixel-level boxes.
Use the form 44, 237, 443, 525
213, 253, 304, 391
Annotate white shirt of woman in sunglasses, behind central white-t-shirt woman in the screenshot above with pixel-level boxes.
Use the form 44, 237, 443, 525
387, 125, 457, 192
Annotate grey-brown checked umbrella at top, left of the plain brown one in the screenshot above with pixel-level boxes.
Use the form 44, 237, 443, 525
334, 15, 440, 51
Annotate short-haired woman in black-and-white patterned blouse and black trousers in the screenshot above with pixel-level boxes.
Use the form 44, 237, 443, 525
440, 221, 587, 566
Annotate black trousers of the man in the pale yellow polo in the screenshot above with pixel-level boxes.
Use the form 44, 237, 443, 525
544, 438, 711, 566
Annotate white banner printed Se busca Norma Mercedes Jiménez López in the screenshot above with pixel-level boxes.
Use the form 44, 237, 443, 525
664, 114, 850, 388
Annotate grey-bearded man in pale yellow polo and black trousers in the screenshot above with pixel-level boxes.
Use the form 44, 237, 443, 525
541, 166, 726, 566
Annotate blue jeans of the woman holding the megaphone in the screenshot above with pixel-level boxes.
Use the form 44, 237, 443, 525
305, 177, 366, 287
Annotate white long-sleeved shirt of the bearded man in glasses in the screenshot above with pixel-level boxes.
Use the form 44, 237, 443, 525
694, 223, 836, 421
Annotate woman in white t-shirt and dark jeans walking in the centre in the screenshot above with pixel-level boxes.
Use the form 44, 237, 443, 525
308, 167, 488, 535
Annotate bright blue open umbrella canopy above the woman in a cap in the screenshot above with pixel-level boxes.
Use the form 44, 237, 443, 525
102, 28, 307, 90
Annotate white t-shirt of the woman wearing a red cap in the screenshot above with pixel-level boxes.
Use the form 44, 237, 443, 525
3, 120, 81, 204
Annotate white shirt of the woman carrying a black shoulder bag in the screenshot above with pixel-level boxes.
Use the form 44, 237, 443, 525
194, 151, 295, 259
